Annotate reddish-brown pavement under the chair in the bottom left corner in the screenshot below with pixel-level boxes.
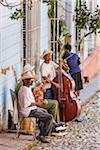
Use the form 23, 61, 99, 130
0, 132, 33, 150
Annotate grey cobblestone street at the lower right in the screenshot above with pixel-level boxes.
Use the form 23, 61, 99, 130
25, 92, 100, 150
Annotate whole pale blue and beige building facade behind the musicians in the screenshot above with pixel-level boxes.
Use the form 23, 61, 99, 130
0, 0, 100, 130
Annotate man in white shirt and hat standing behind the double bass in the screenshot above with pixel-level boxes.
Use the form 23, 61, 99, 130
40, 50, 60, 99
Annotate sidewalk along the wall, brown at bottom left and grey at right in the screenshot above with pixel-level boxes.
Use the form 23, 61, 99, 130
0, 74, 100, 150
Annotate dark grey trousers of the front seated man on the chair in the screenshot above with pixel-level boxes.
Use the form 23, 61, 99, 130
29, 107, 54, 136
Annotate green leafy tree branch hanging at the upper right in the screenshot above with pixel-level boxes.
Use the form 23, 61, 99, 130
75, 1, 100, 51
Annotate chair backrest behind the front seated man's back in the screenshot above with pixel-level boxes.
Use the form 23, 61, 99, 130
10, 89, 18, 124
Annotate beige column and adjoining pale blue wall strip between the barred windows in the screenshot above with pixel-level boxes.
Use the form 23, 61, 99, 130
23, 0, 48, 74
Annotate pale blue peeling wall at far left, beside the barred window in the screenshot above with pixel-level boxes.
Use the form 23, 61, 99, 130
0, 0, 21, 130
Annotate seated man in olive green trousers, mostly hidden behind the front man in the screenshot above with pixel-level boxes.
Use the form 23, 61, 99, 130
15, 64, 59, 122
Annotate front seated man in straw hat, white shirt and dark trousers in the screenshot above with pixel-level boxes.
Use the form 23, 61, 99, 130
18, 72, 54, 143
